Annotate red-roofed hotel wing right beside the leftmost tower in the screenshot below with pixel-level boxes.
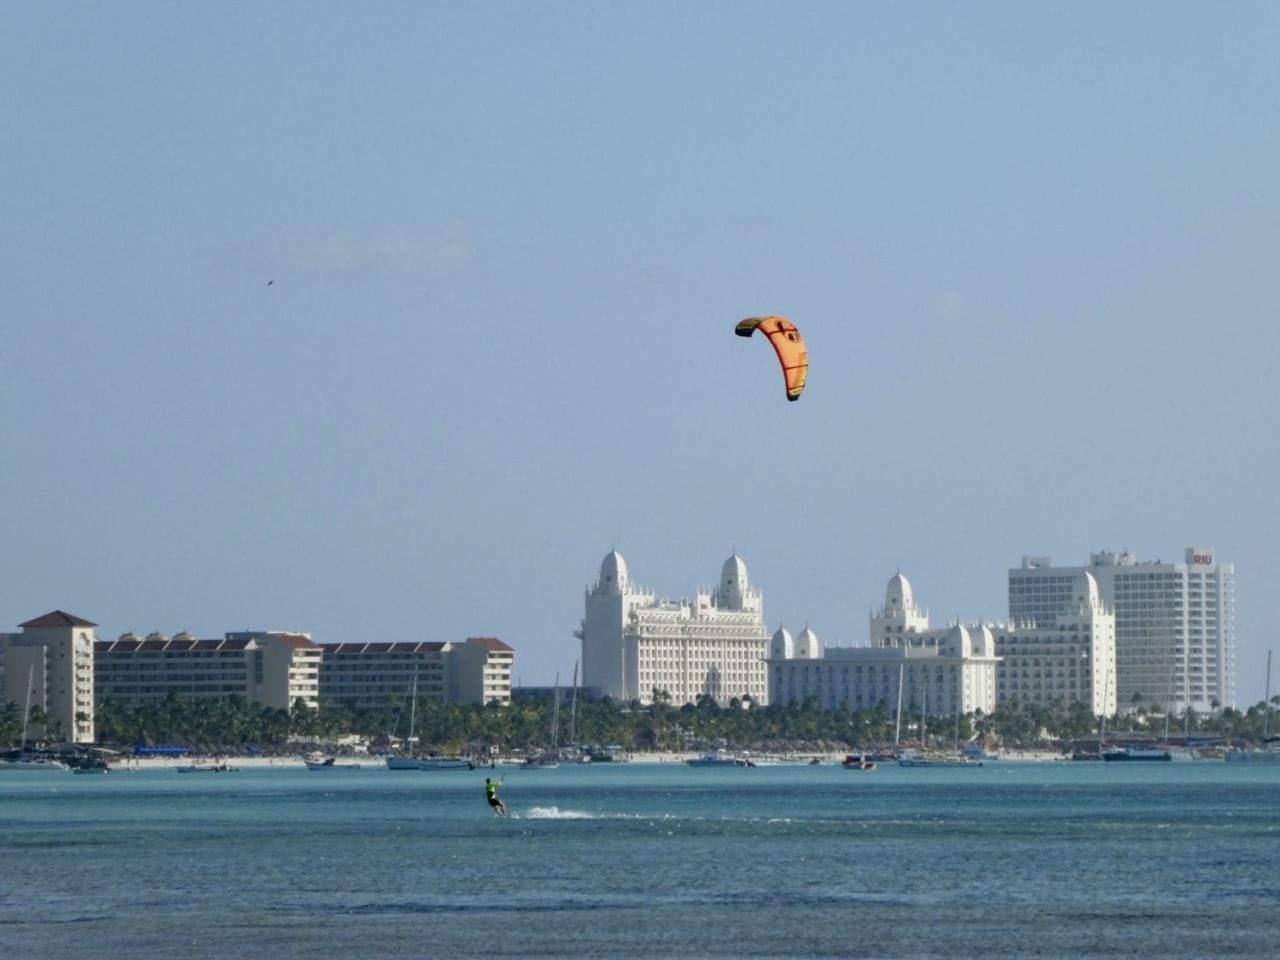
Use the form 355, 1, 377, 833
95, 631, 321, 710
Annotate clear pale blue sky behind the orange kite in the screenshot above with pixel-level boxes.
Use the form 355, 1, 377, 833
0, 0, 1280, 704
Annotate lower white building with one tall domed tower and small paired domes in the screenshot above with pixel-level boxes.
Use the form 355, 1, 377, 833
768, 573, 998, 717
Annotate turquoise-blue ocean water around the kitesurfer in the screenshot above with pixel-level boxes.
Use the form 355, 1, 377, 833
0, 760, 1280, 960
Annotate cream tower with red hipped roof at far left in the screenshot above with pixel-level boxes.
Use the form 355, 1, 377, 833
0, 611, 97, 744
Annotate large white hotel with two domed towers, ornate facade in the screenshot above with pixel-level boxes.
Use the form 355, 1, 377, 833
573, 550, 769, 707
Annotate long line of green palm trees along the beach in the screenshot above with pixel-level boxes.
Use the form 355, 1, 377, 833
0, 690, 1280, 754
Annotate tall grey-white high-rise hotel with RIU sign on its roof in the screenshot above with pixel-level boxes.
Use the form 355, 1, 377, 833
1009, 547, 1235, 713
